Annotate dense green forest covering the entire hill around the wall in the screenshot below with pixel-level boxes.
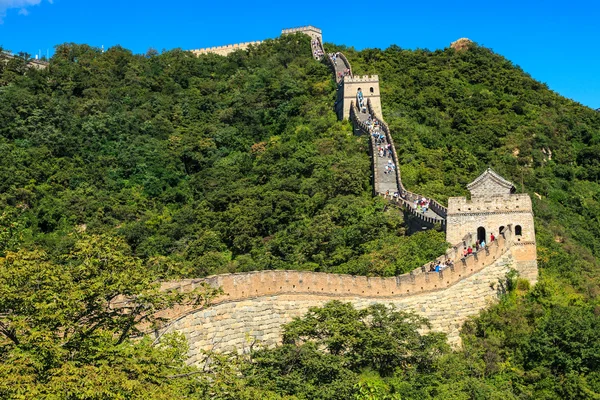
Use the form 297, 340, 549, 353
0, 35, 600, 399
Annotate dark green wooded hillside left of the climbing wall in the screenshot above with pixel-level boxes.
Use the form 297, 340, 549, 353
0, 38, 444, 277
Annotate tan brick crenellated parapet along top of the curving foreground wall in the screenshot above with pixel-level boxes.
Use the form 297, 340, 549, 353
156, 229, 512, 328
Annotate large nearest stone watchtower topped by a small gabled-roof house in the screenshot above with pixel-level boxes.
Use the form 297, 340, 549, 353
446, 168, 538, 283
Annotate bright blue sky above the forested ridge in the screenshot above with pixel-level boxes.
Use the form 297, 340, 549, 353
0, 0, 600, 108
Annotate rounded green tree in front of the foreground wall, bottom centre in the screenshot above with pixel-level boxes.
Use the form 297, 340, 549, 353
239, 301, 448, 399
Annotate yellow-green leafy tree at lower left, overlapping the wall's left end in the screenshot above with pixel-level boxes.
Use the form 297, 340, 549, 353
0, 235, 218, 399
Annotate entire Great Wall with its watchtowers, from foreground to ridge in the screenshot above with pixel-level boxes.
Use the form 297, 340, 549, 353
154, 26, 538, 363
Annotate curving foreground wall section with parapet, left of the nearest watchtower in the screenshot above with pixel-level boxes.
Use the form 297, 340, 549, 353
155, 230, 513, 362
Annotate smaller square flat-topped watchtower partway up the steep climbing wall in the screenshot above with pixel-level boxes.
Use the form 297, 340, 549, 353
337, 75, 382, 119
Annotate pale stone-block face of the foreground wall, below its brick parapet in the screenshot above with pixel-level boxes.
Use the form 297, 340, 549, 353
157, 251, 512, 363
